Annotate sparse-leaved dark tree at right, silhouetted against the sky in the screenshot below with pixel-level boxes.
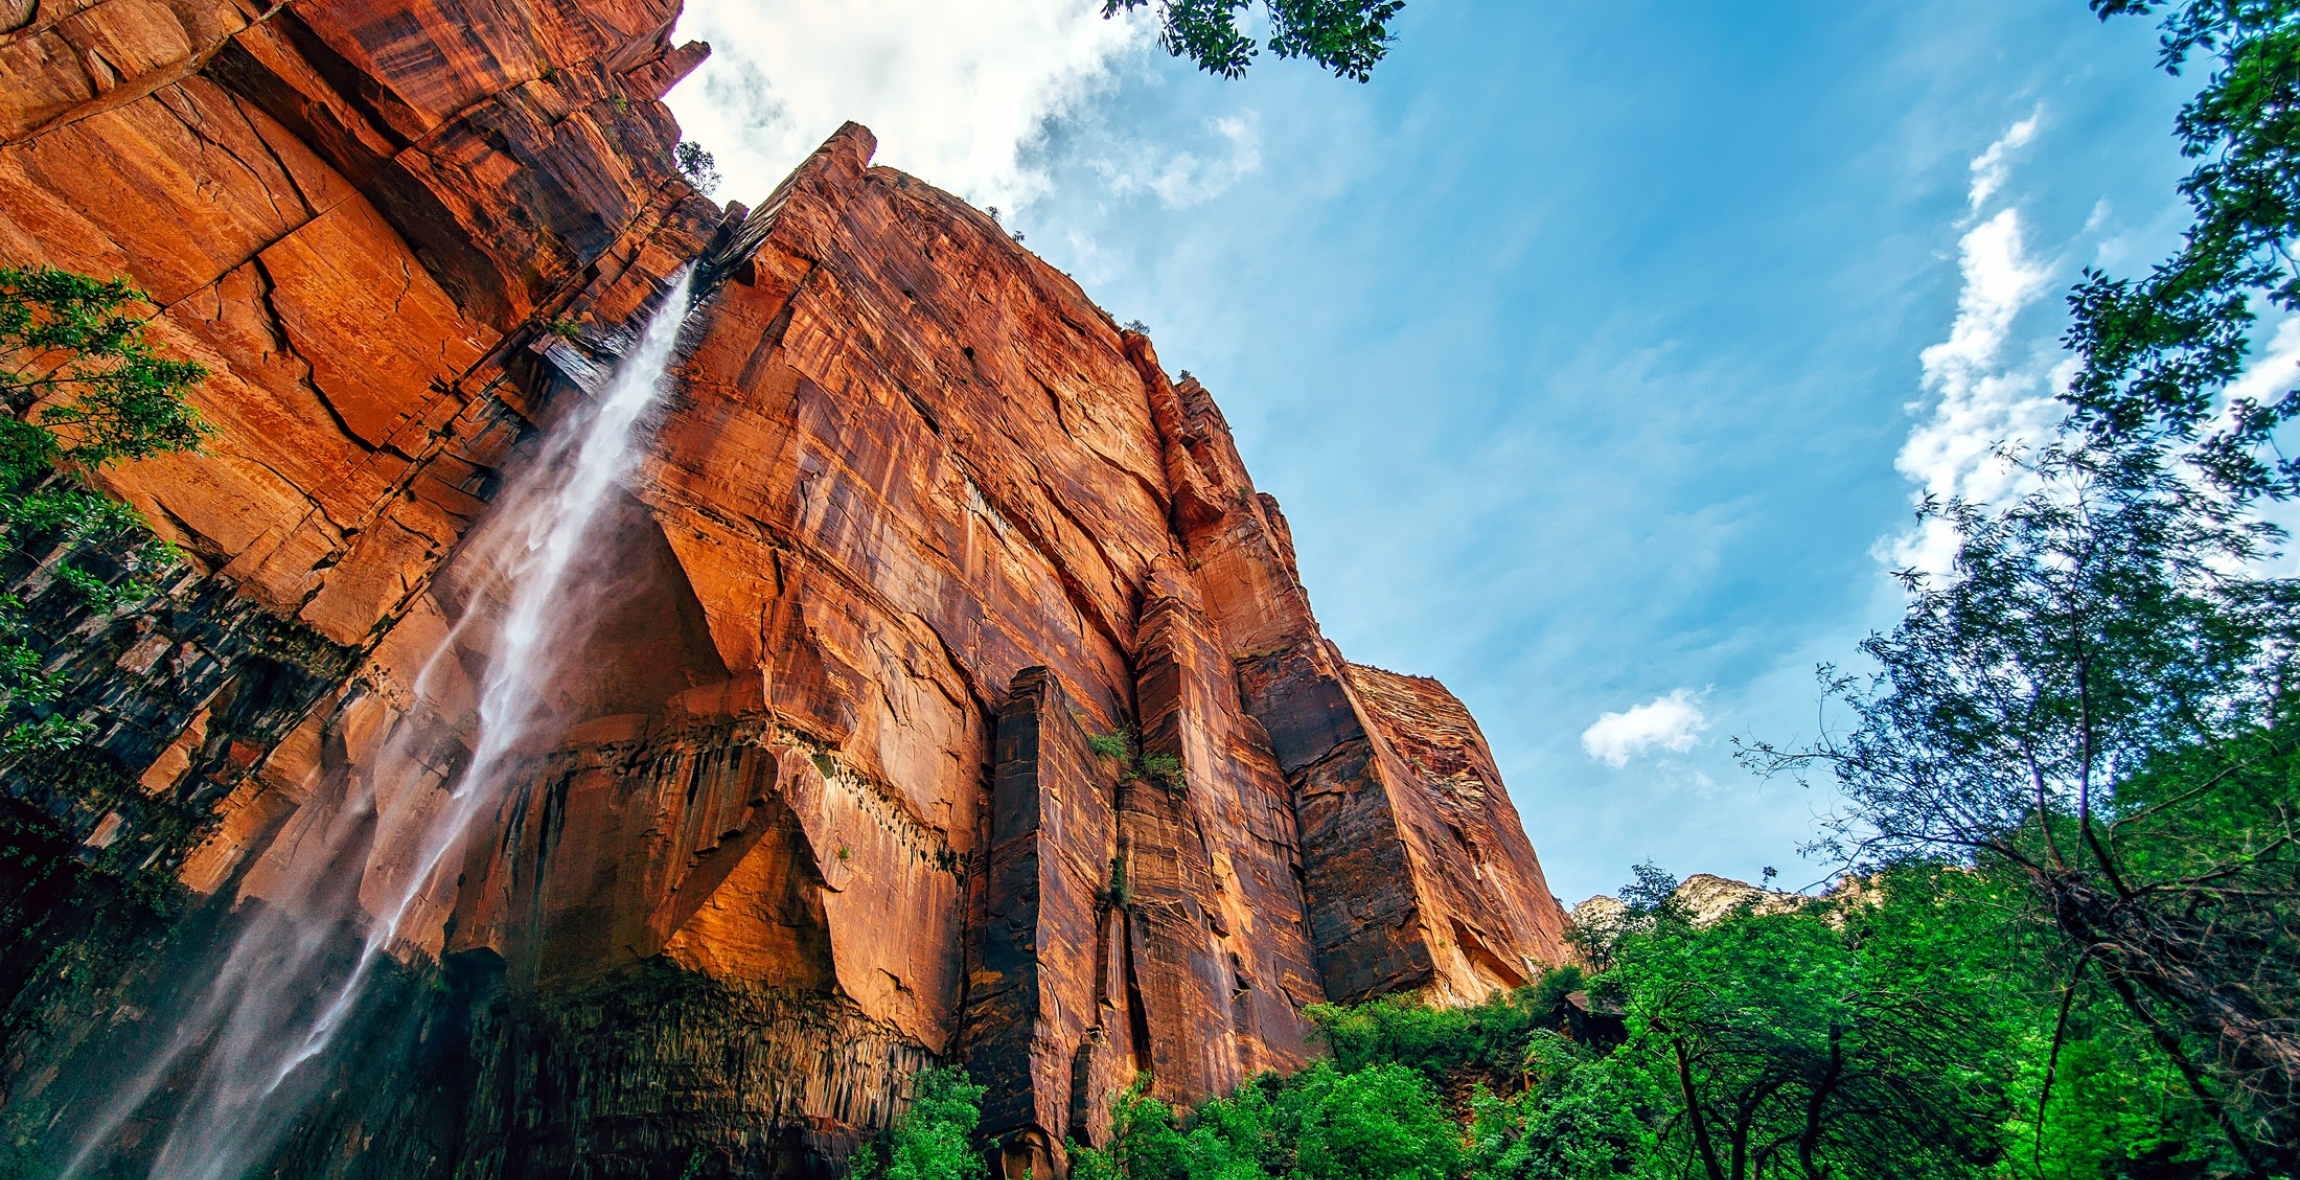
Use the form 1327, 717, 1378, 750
1748, 437, 2300, 1175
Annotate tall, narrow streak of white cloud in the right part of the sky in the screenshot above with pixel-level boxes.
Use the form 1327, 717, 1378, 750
1888, 115, 2070, 573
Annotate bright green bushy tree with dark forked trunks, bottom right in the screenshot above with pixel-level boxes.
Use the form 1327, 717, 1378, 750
1599, 869, 2003, 1180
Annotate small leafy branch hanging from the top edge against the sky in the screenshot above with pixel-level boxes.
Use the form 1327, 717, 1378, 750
1102, 0, 1405, 83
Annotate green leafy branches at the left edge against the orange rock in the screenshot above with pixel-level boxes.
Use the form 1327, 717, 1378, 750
0, 267, 207, 752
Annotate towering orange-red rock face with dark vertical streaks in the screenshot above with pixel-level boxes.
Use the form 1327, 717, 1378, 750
0, 0, 1566, 1175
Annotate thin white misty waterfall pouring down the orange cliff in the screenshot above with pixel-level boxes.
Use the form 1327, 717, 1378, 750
64, 269, 690, 1180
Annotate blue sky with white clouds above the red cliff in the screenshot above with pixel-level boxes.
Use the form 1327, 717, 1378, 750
674, 0, 2217, 904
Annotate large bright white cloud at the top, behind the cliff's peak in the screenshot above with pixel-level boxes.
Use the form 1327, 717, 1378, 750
669, 0, 1152, 207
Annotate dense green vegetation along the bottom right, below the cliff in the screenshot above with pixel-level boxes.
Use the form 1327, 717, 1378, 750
858, 851, 2300, 1180
